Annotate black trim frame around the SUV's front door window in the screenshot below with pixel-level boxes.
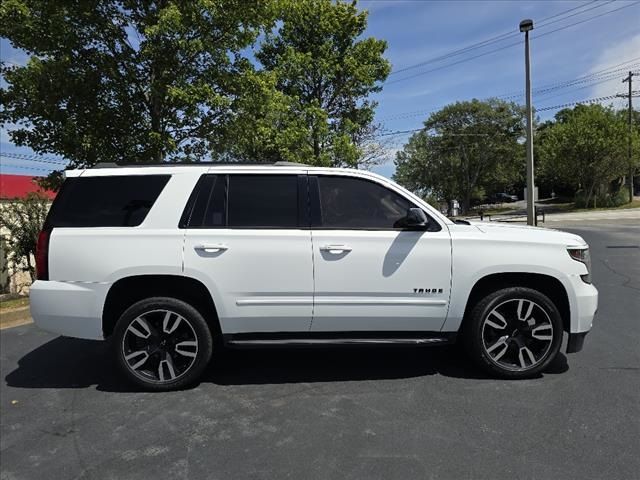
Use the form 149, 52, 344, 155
309, 174, 442, 232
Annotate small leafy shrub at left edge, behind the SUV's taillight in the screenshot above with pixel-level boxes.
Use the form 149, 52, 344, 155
0, 193, 49, 282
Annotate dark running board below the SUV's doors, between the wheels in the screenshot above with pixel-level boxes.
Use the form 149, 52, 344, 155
225, 335, 453, 347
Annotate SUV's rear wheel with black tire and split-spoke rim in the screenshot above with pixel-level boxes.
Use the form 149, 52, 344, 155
112, 297, 213, 391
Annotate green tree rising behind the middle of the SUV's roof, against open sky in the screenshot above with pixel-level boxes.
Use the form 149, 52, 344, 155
256, 0, 390, 166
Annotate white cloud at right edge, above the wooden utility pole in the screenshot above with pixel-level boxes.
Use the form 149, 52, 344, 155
589, 34, 640, 103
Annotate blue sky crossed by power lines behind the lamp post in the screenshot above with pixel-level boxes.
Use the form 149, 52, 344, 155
0, 0, 640, 176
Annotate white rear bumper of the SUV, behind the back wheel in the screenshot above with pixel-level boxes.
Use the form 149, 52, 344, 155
29, 280, 109, 340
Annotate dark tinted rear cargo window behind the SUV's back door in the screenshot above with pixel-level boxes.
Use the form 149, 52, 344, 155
47, 175, 170, 227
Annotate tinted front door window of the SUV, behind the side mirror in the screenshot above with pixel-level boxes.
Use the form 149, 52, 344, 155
318, 176, 414, 229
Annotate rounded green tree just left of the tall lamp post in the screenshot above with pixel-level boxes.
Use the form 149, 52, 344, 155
394, 99, 524, 212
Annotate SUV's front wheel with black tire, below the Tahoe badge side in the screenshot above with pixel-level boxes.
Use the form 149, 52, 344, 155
463, 287, 563, 379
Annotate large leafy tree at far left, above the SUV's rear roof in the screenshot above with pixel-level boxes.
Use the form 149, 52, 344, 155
0, 0, 275, 172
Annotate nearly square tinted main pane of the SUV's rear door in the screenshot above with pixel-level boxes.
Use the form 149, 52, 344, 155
227, 175, 298, 228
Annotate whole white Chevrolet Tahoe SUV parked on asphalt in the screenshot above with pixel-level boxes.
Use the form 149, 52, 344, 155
31, 163, 598, 390
